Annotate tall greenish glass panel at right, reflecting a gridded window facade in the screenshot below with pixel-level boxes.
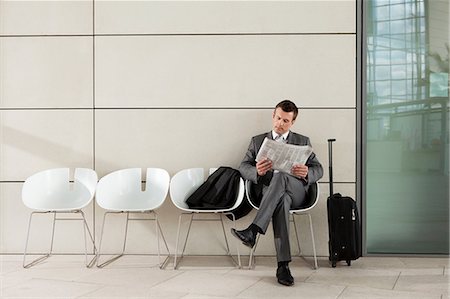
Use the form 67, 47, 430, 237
363, 0, 449, 254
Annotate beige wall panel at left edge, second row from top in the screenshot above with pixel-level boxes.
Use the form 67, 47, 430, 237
0, 37, 93, 108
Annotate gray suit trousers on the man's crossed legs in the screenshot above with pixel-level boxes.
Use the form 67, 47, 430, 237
253, 172, 306, 262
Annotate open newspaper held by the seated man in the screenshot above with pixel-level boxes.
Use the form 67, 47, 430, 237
256, 137, 313, 174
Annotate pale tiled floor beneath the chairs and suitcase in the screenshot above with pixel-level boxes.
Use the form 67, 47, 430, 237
0, 256, 450, 299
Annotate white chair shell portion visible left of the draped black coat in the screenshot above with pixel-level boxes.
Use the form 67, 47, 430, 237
170, 168, 205, 210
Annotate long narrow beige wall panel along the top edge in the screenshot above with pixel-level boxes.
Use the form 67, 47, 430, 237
95, 0, 356, 34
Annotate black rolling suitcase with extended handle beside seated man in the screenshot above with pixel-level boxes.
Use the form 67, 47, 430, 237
327, 139, 361, 268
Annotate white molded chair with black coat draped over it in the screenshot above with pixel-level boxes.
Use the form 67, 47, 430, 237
170, 168, 245, 269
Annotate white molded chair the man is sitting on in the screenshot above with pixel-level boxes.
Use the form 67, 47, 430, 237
245, 180, 320, 269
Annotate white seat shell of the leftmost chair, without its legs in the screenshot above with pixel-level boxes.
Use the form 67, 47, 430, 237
22, 168, 97, 211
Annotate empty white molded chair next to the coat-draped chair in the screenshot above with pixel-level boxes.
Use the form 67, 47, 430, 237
96, 168, 170, 268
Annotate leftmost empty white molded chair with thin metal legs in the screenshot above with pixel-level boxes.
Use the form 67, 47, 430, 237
22, 168, 97, 268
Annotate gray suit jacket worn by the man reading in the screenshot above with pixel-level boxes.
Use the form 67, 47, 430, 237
239, 131, 323, 189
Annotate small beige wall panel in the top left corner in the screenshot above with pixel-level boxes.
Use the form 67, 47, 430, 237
0, 0, 93, 35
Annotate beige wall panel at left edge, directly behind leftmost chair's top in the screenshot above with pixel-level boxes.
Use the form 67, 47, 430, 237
0, 110, 93, 181
